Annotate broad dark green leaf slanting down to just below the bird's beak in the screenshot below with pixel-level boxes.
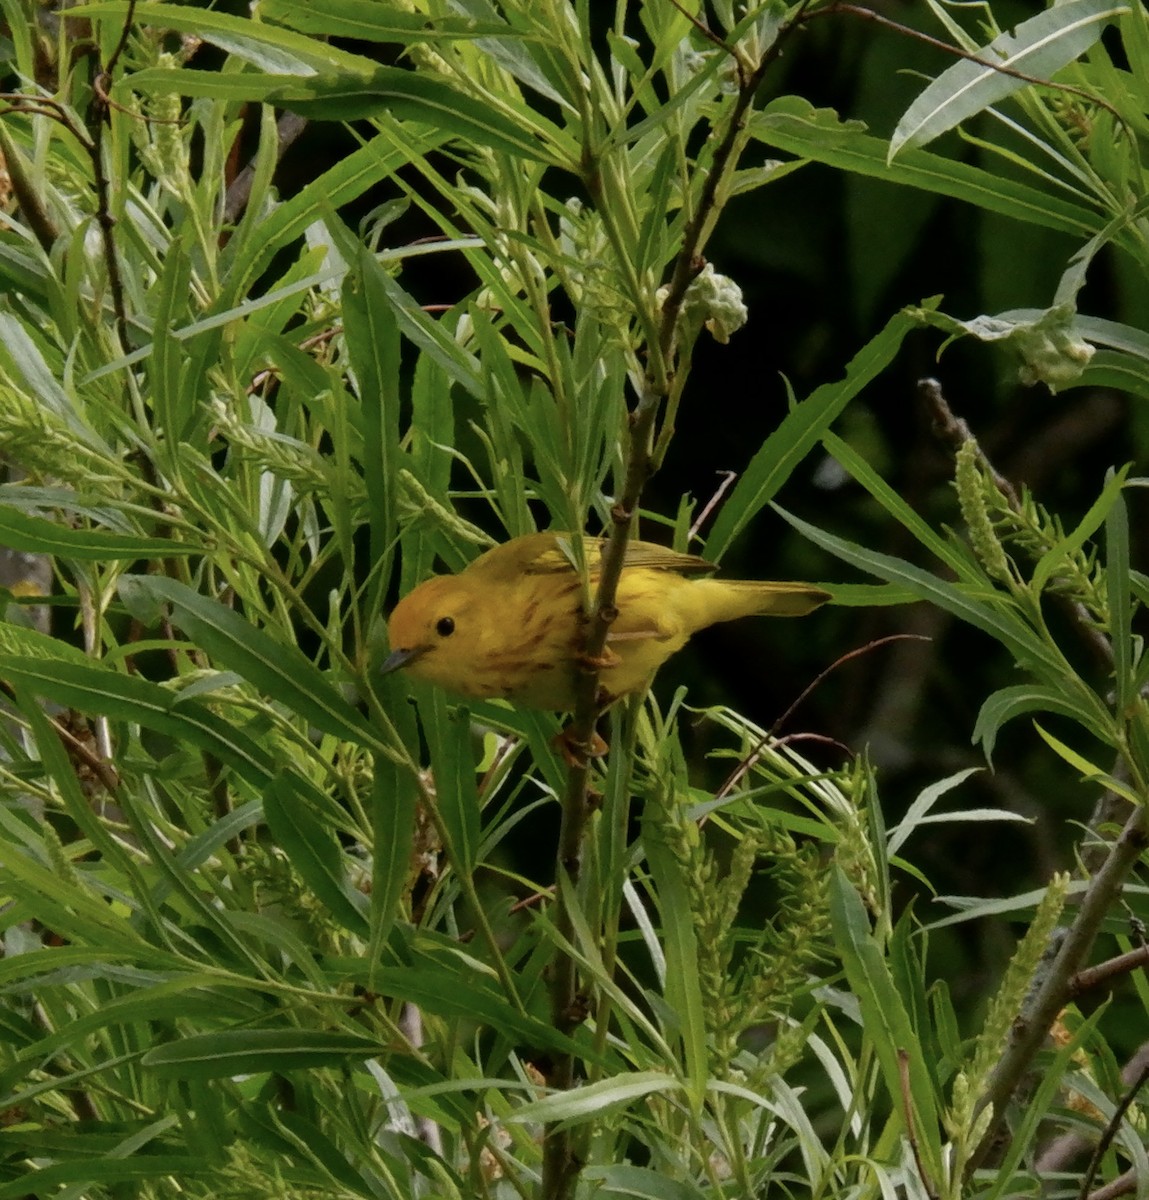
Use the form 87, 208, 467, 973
120, 575, 381, 748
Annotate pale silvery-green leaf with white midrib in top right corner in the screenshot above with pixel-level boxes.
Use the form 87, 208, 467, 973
890, 0, 1129, 161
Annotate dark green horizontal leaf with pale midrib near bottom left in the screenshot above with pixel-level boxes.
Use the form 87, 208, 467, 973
140, 1030, 389, 1079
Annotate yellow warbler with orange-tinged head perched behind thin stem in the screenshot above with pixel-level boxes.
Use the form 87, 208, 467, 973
383, 533, 830, 712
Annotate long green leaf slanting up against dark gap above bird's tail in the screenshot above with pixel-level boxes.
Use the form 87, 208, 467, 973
703, 302, 914, 563
